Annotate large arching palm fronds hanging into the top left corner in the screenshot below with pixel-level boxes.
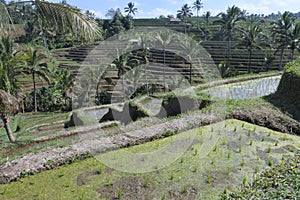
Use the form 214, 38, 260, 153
0, 0, 101, 47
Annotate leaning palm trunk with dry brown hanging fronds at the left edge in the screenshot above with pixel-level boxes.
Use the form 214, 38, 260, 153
0, 89, 18, 142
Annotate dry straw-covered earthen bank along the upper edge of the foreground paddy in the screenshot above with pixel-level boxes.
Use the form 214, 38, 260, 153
0, 114, 221, 184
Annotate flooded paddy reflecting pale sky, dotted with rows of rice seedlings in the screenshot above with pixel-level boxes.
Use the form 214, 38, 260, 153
205, 76, 281, 99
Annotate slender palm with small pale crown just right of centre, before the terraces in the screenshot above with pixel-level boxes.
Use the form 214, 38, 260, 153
154, 30, 174, 92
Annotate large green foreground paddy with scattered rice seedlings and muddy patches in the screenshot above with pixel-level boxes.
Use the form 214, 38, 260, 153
0, 120, 300, 199
